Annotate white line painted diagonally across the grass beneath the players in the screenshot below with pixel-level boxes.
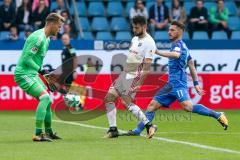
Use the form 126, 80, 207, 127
53, 120, 240, 154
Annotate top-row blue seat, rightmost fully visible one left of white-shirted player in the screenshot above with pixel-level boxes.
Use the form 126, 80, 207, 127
107, 2, 123, 17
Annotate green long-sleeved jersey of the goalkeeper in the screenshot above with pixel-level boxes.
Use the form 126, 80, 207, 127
14, 29, 50, 75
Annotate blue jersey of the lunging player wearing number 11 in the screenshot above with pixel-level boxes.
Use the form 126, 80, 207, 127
168, 40, 191, 88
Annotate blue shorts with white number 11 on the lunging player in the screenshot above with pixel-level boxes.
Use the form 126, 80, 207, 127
153, 84, 190, 108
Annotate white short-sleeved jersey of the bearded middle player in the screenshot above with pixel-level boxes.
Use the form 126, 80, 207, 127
124, 34, 156, 79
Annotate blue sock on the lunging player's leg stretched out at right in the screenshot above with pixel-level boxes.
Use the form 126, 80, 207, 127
192, 104, 221, 119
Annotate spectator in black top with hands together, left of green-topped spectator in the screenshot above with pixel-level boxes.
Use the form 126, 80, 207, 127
188, 0, 209, 38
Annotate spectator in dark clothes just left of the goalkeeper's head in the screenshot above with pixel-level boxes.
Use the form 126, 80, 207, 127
32, 0, 49, 30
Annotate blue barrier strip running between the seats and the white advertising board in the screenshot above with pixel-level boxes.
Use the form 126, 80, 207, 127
0, 40, 240, 50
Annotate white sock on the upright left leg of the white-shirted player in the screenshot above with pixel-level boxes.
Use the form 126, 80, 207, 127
106, 103, 117, 127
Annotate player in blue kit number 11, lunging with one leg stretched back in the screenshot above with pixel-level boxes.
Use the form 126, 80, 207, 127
126, 21, 228, 136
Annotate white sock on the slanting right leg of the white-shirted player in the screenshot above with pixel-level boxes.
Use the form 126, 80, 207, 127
128, 104, 149, 125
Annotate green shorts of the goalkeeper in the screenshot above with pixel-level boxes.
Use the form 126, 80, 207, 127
14, 75, 46, 98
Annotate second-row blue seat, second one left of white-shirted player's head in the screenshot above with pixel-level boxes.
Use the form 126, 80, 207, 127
92, 17, 109, 31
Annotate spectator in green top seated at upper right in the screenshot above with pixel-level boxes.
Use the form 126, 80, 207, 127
209, 0, 231, 38
